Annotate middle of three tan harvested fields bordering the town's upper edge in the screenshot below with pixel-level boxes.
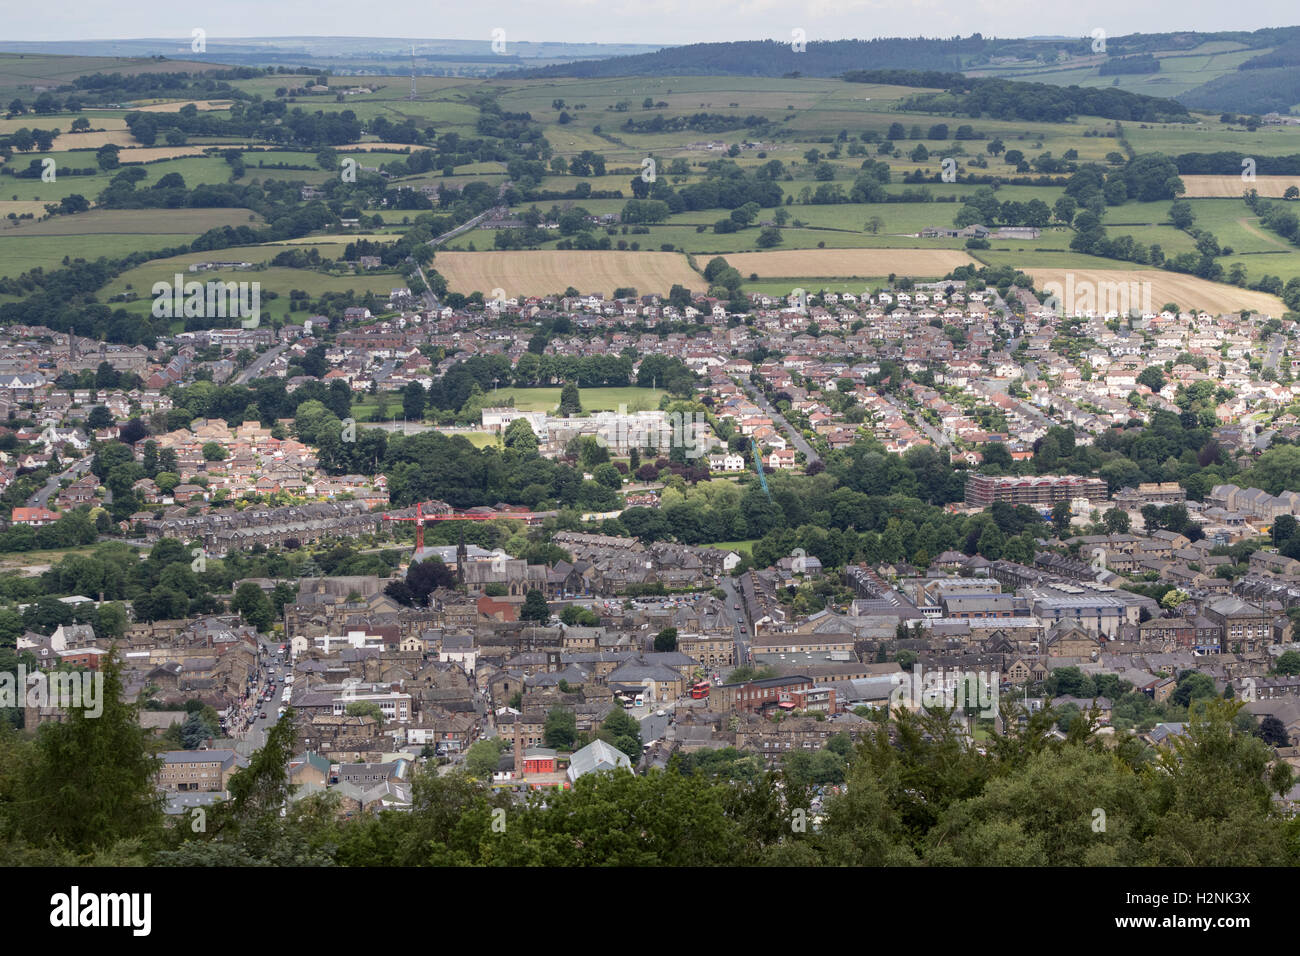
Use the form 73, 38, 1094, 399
723, 248, 975, 278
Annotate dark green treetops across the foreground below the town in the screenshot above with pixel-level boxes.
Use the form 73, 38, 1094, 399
0, 659, 1300, 866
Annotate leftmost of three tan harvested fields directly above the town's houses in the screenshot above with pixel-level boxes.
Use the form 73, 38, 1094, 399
433, 250, 707, 298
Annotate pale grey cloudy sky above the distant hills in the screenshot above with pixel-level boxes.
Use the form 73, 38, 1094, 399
0, 0, 1300, 43
